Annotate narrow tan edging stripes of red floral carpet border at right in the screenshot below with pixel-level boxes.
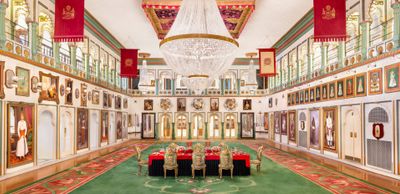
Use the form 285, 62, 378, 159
242, 142, 396, 193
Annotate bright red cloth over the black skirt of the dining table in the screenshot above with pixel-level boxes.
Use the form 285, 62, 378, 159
149, 152, 250, 168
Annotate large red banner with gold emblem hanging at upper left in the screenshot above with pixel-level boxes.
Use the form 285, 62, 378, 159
54, 0, 85, 42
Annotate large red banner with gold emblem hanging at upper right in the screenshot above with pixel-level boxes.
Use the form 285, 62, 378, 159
314, 0, 346, 42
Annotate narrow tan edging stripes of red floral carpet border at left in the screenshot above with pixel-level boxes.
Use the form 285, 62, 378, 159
7, 142, 154, 194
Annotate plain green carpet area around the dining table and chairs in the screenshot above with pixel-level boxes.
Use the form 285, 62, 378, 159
73, 143, 329, 194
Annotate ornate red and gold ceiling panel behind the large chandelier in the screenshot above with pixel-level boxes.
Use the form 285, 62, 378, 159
142, 0, 255, 39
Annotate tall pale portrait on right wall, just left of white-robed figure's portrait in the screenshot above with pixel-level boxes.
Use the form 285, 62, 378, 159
309, 109, 321, 150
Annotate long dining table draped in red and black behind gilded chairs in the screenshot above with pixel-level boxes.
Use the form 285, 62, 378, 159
148, 149, 250, 176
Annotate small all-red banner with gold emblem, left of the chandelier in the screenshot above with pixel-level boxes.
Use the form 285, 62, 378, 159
120, 49, 138, 77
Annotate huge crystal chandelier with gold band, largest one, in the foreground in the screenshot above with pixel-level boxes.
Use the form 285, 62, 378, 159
160, 0, 239, 95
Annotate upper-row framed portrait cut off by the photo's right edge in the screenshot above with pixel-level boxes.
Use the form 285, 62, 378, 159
385, 64, 400, 93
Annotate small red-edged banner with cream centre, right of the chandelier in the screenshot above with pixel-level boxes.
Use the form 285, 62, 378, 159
258, 48, 276, 77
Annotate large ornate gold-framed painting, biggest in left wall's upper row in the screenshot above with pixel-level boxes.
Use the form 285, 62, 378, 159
39, 71, 60, 104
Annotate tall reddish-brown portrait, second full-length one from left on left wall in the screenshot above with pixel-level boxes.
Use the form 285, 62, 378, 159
76, 108, 89, 150
